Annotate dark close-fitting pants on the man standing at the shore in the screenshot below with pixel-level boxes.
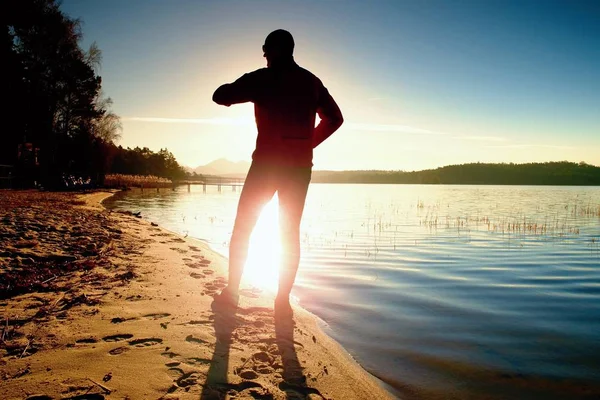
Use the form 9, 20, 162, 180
229, 163, 311, 296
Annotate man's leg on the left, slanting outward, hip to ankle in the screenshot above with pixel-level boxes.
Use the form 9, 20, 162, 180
227, 164, 275, 294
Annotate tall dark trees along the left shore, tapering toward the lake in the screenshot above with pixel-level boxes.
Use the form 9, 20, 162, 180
0, 0, 186, 187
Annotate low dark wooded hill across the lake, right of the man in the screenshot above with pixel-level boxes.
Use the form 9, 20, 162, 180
311, 161, 600, 186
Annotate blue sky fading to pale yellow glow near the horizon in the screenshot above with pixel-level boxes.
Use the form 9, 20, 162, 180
61, 0, 600, 171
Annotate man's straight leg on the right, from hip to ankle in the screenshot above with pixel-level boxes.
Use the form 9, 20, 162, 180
276, 168, 311, 307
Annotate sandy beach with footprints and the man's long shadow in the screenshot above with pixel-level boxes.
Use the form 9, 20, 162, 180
0, 191, 393, 400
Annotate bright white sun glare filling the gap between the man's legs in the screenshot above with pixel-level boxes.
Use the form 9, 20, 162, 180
243, 195, 281, 293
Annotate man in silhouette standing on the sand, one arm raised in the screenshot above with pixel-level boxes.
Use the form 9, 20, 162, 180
213, 29, 343, 313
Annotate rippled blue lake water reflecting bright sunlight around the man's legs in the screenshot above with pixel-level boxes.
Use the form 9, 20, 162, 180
107, 184, 600, 399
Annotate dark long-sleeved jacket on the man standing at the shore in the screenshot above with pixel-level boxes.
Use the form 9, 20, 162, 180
213, 60, 343, 167
